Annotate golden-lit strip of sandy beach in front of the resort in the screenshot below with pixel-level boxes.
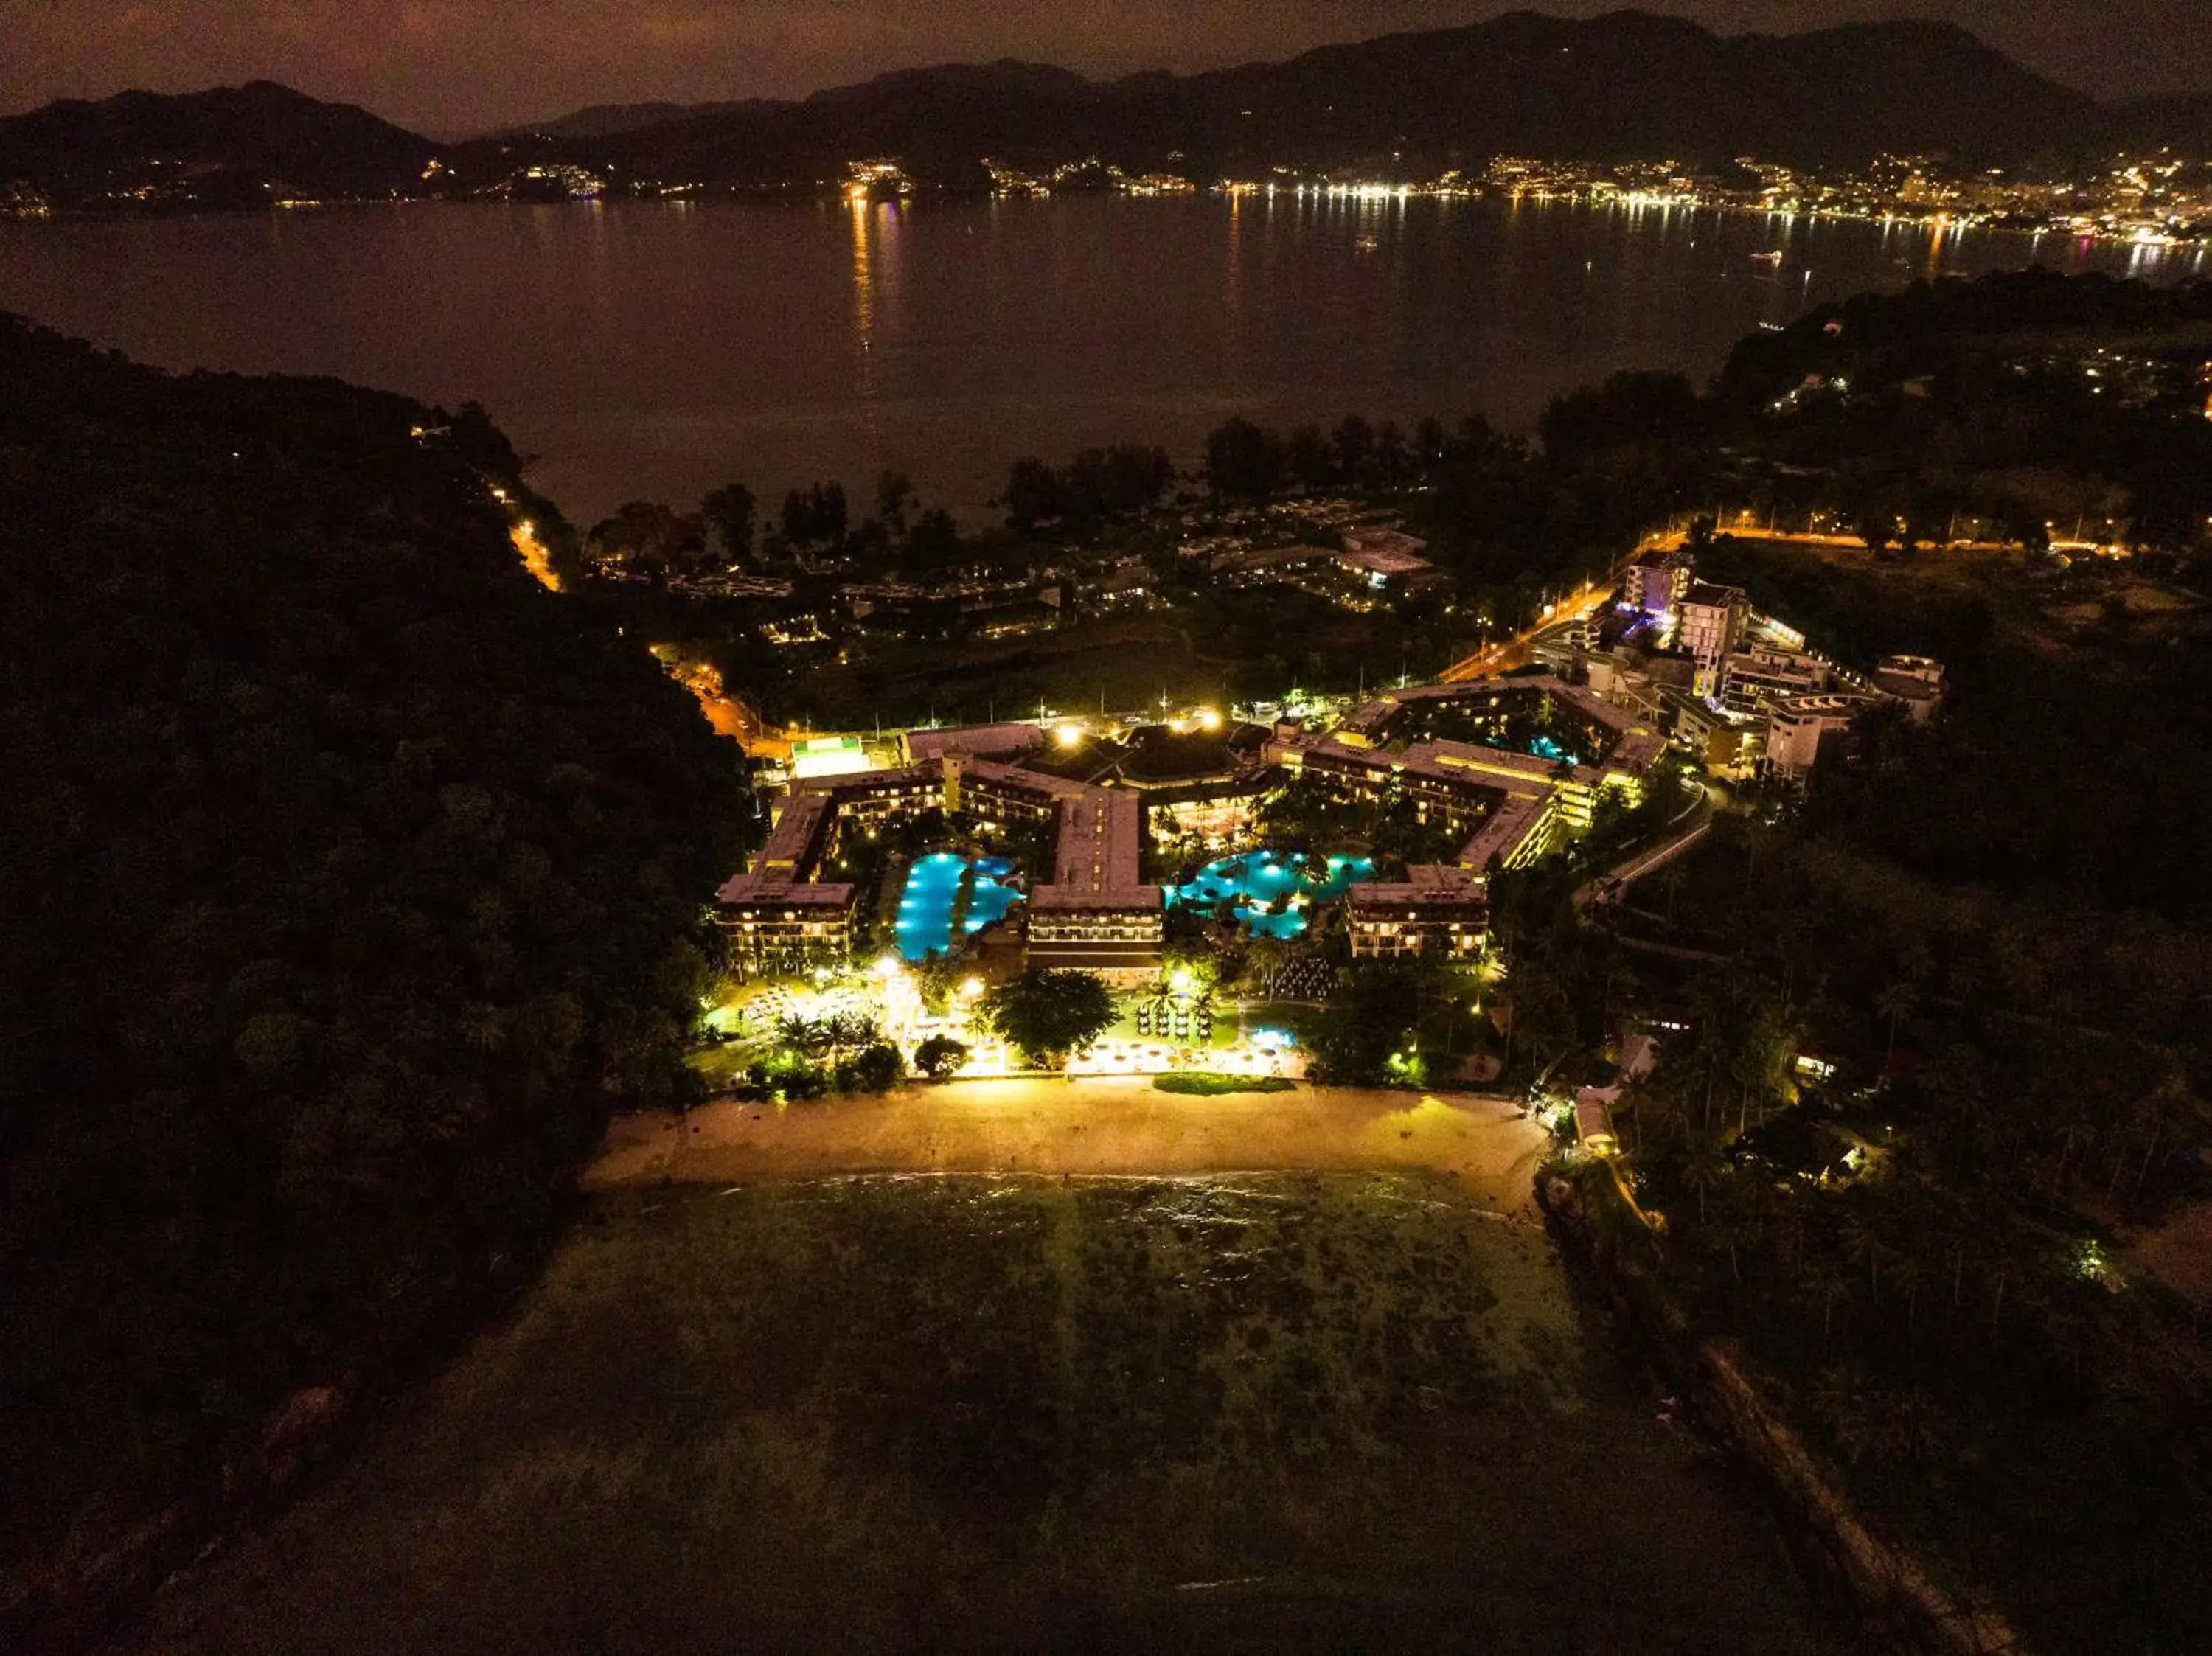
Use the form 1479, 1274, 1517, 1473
584, 1076, 1546, 1216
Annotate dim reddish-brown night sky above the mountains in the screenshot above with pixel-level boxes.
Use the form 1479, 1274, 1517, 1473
0, 0, 2212, 137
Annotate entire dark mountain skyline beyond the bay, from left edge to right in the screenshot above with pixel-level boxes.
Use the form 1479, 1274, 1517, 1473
0, 11, 2208, 203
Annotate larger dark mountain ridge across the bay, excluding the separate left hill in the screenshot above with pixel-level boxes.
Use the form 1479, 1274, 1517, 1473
535, 11, 2108, 184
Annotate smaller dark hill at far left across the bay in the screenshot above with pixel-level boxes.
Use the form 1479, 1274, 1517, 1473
0, 80, 438, 206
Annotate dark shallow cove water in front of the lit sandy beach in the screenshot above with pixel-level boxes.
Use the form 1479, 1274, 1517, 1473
135, 1176, 1825, 1656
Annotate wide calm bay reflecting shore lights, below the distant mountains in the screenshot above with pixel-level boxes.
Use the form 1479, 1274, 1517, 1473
0, 190, 2205, 524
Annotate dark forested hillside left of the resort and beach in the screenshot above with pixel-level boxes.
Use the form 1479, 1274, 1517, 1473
0, 319, 739, 1649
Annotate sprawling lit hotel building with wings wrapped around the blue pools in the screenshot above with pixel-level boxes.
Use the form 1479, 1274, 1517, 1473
719, 677, 1666, 981
